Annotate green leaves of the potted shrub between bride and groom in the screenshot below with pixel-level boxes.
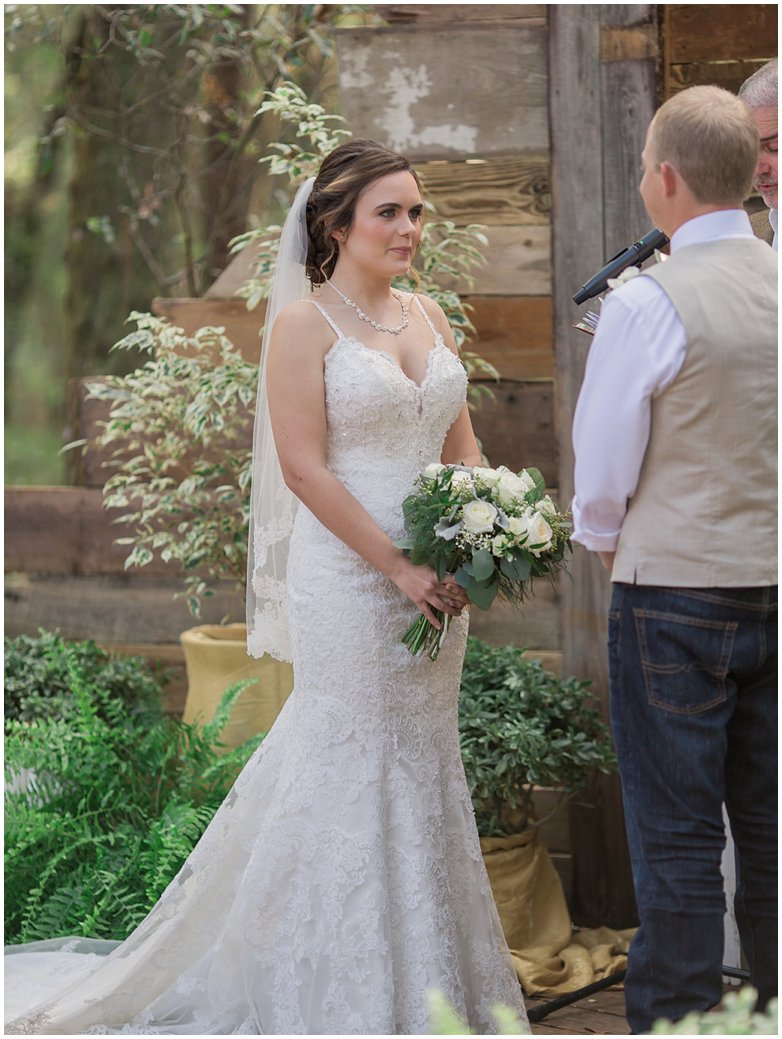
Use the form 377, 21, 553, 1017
459, 638, 616, 836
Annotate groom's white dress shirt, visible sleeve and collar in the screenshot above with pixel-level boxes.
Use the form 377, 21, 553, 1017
571, 209, 756, 552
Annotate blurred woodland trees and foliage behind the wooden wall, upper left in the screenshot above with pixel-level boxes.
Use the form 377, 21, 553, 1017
4, 4, 377, 484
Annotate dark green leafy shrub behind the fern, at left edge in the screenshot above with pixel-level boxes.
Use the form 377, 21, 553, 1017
4, 630, 165, 721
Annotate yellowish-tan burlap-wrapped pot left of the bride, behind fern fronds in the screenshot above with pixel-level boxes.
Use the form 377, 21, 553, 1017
180, 624, 293, 747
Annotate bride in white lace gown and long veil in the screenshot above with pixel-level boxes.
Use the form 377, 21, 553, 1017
6, 140, 524, 1035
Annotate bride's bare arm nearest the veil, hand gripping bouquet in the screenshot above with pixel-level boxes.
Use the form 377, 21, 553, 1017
266, 303, 465, 628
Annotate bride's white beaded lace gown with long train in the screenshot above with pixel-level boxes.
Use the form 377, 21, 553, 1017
5, 299, 524, 1035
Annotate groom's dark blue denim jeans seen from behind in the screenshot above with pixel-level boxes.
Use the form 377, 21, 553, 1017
609, 584, 777, 1033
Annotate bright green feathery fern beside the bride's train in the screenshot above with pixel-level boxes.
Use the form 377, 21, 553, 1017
5, 646, 261, 943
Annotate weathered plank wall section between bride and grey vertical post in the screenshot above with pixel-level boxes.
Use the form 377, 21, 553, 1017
336, 4, 557, 484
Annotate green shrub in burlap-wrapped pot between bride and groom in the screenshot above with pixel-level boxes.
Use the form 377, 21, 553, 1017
459, 638, 614, 992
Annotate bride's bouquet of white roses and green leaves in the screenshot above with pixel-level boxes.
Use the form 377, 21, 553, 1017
396, 462, 570, 660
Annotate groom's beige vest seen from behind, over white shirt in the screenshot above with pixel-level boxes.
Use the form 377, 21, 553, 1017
612, 238, 778, 588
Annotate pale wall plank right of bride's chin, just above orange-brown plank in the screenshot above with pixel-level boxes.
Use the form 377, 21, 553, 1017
434, 225, 551, 296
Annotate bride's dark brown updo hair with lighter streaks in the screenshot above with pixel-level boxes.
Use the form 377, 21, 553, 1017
305, 138, 421, 285
